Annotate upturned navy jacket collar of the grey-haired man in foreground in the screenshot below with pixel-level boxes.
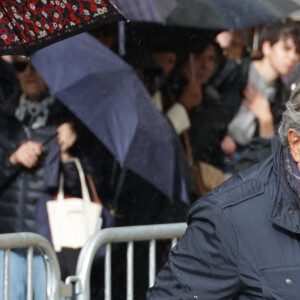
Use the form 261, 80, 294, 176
270, 146, 300, 233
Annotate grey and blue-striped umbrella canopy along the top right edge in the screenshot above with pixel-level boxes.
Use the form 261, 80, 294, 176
112, 0, 300, 30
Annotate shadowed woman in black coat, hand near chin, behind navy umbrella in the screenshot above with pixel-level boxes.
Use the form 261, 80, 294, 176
172, 42, 228, 169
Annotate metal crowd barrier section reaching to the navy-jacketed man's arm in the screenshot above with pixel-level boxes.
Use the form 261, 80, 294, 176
70, 223, 187, 300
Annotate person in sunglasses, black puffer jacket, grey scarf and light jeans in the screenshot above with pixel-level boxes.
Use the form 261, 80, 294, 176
0, 57, 82, 300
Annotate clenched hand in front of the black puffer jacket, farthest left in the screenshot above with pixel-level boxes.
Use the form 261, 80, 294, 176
9, 141, 43, 169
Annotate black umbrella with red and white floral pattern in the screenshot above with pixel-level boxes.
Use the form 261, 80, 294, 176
0, 0, 124, 55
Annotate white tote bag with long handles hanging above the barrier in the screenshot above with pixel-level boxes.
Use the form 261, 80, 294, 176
46, 158, 102, 252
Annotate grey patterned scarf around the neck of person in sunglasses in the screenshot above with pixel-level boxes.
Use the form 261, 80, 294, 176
15, 94, 55, 130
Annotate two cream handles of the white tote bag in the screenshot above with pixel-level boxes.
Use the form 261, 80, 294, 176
57, 158, 91, 202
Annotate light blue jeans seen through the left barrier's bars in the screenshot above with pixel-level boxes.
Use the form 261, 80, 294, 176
0, 250, 46, 300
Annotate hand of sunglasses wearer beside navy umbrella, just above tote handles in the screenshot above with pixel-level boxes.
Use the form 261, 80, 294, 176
57, 122, 77, 161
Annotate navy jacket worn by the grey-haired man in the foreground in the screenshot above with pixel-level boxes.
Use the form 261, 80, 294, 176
147, 143, 300, 300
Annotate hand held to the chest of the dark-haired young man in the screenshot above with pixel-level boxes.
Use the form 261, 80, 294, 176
242, 85, 275, 137
